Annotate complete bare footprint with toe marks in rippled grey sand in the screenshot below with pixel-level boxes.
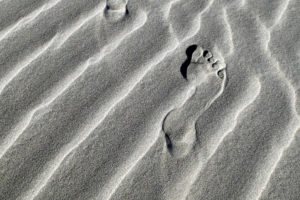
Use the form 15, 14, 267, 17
162, 47, 227, 157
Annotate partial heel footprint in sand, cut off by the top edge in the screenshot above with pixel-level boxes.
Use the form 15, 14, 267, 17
104, 0, 129, 22
